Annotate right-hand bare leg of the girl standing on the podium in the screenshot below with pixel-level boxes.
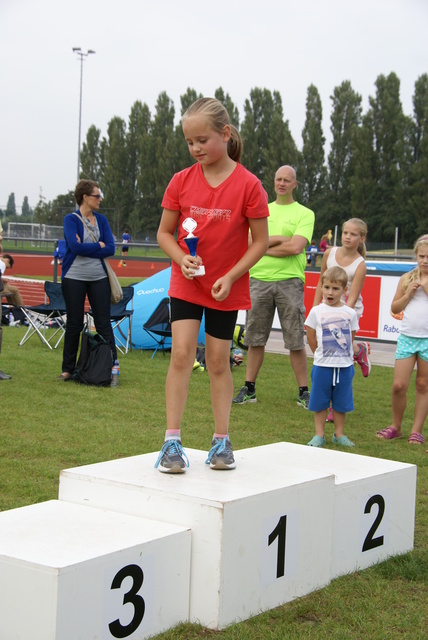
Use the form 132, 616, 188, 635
205, 334, 233, 435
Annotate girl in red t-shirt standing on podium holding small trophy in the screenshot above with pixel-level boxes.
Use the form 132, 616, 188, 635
155, 98, 269, 473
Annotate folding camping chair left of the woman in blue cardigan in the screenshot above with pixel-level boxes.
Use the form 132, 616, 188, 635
19, 281, 67, 349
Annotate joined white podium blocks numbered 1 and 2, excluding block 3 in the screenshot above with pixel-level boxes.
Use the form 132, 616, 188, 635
59, 442, 416, 629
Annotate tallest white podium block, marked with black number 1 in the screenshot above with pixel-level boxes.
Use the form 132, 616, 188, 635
59, 445, 335, 628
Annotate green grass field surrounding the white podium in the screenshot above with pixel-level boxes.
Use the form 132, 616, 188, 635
0, 328, 428, 640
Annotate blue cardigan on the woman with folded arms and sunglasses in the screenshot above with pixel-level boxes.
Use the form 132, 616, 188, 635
61, 209, 116, 280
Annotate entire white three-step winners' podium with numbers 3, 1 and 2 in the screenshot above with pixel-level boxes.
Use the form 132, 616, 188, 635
0, 442, 416, 640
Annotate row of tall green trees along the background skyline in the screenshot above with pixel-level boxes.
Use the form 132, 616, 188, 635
6, 73, 428, 246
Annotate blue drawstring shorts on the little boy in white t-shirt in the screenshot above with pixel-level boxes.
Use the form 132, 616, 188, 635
308, 364, 354, 413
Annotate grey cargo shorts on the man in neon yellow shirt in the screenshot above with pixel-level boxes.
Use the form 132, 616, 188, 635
245, 278, 305, 351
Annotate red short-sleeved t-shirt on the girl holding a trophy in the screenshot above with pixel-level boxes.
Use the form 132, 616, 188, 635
162, 164, 269, 311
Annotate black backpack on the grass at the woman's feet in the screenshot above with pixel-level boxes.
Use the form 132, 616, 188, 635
72, 331, 113, 387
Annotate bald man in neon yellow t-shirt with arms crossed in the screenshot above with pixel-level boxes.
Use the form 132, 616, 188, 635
233, 165, 315, 409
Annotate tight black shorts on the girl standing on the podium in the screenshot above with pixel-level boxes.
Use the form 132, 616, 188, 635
171, 298, 238, 340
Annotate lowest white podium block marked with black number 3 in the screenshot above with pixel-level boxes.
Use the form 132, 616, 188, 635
0, 500, 191, 640
